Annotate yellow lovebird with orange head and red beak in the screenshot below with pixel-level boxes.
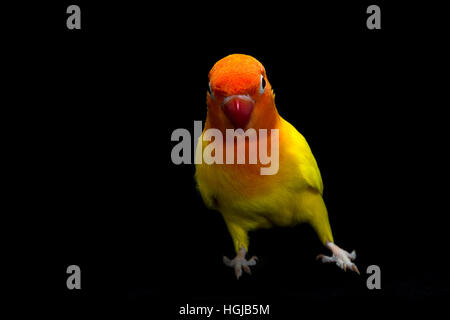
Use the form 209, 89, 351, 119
195, 54, 359, 279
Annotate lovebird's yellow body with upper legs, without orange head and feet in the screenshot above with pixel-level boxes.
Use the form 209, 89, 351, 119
195, 116, 333, 251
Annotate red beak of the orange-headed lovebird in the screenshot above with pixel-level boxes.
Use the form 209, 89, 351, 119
223, 96, 255, 129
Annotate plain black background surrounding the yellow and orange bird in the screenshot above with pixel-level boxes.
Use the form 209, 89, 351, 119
10, 1, 449, 319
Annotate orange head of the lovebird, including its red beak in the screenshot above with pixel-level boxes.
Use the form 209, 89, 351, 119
205, 54, 278, 132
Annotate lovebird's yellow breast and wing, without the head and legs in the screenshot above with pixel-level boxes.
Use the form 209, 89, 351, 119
195, 117, 322, 230
